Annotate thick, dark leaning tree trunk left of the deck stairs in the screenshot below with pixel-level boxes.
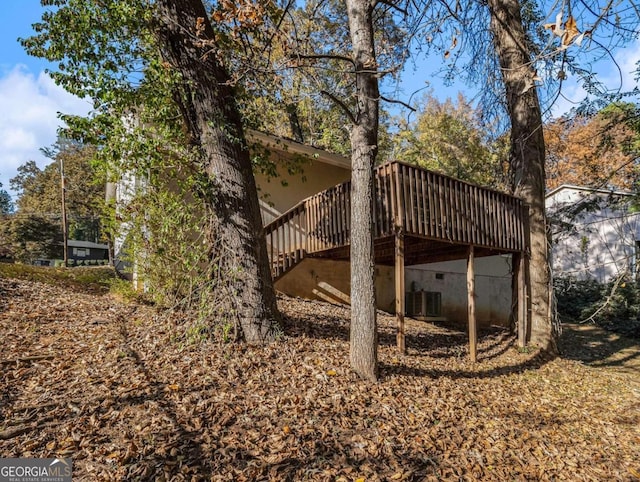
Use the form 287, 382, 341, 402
157, 0, 279, 343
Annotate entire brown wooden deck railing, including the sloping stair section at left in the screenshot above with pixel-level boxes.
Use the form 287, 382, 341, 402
264, 162, 527, 277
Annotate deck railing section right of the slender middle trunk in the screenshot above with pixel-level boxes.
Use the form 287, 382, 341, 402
375, 162, 526, 251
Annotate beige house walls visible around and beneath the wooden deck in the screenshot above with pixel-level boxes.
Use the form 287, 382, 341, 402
251, 133, 524, 326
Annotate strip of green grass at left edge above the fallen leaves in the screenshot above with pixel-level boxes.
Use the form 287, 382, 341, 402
0, 263, 118, 293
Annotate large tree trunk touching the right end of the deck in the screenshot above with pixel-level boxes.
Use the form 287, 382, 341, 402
488, 0, 556, 352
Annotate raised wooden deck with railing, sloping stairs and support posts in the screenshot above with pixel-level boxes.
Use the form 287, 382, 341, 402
265, 162, 528, 359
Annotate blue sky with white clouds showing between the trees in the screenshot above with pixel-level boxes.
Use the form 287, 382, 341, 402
0, 0, 640, 203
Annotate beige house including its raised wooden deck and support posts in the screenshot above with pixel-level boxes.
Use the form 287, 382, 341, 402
115, 131, 528, 358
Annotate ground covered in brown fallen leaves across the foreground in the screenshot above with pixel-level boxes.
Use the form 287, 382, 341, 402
0, 278, 640, 481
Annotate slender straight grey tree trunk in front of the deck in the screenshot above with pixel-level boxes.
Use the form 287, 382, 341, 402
346, 0, 379, 381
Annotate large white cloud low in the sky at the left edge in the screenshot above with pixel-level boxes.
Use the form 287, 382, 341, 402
0, 65, 91, 197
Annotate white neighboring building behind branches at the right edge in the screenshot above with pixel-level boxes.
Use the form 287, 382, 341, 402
546, 185, 640, 283
